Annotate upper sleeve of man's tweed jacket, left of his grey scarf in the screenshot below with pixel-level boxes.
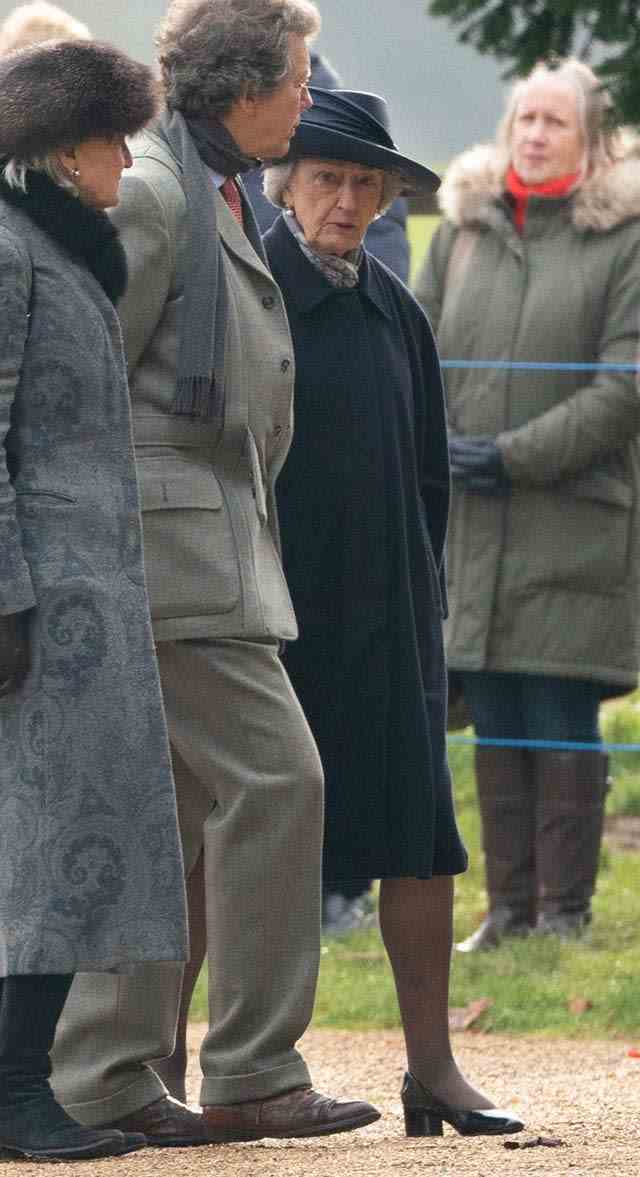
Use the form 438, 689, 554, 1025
109, 172, 175, 374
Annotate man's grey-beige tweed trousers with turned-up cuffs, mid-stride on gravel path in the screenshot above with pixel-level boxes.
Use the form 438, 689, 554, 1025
53, 639, 322, 1125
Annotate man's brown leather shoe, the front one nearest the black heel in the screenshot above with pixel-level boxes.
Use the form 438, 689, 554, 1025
202, 1086, 380, 1143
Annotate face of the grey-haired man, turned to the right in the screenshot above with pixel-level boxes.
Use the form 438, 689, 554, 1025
241, 33, 313, 159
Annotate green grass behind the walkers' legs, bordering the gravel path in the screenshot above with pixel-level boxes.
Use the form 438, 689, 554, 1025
192, 696, 640, 1038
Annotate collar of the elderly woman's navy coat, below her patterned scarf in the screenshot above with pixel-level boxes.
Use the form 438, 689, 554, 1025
264, 214, 392, 319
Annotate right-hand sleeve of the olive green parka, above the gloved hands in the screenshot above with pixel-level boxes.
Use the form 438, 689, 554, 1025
496, 227, 640, 485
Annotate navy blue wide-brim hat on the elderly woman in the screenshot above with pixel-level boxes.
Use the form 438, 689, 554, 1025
286, 86, 440, 192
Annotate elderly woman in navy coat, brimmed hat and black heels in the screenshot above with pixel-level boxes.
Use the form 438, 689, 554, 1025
265, 91, 522, 1135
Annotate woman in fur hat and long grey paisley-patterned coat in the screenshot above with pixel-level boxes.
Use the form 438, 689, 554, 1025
0, 41, 186, 1158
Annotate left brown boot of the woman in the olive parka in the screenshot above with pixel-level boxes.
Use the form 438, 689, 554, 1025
455, 745, 535, 952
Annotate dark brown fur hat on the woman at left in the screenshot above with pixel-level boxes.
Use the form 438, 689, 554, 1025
0, 41, 158, 160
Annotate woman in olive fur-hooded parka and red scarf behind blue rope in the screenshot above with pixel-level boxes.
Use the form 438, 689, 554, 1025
418, 60, 640, 952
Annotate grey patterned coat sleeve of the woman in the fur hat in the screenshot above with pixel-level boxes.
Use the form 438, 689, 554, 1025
0, 228, 35, 616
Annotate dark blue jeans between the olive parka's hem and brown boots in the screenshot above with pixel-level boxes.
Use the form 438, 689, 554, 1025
461, 671, 601, 744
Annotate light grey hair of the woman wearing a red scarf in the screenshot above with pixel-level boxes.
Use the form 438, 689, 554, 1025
496, 58, 624, 180
